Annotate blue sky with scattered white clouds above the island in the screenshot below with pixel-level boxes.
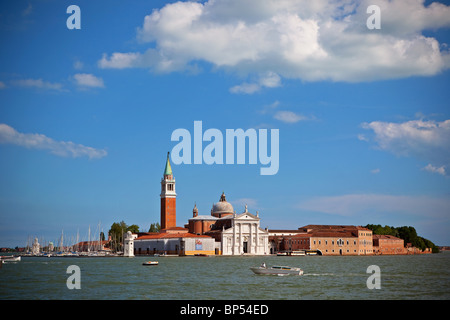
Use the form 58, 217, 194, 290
0, 0, 450, 246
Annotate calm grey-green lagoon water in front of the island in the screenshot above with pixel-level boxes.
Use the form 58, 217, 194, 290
0, 252, 450, 300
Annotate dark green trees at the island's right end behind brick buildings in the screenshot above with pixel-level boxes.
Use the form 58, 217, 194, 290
365, 224, 439, 253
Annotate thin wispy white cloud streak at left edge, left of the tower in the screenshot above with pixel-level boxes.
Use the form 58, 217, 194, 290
0, 124, 107, 159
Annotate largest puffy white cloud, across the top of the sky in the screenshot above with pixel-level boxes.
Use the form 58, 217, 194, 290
99, 0, 450, 84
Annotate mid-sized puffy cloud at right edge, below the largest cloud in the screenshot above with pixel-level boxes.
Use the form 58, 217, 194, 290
361, 120, 450, 174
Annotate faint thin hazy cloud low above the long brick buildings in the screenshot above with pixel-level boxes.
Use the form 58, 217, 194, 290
297, 194, 450, 217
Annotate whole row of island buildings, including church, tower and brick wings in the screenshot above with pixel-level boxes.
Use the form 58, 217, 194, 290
123, 154, 431, 257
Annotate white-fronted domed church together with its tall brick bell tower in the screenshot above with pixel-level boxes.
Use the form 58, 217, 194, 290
124, 153, 269, 257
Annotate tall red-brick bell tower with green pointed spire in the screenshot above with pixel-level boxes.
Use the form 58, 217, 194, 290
160, 152, 177, 229
